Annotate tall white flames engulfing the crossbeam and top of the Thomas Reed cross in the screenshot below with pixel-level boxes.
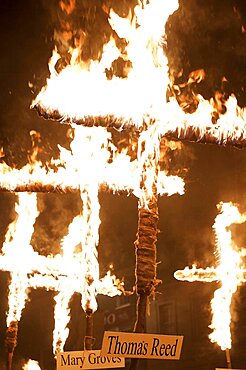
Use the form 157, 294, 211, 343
31, 0, 246, 145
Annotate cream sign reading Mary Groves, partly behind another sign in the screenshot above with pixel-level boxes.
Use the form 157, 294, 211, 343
56, 350, 125, 370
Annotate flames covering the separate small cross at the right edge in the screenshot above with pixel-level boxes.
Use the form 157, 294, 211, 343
174, 202, 246, 350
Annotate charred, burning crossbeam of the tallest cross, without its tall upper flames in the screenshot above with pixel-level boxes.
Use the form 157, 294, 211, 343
33, 96, 246, 148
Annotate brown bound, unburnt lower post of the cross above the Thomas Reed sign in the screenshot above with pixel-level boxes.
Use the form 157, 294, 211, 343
130, 197, 159, 370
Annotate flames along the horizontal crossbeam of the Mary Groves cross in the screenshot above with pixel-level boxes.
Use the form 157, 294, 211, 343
0, 126, 184, 197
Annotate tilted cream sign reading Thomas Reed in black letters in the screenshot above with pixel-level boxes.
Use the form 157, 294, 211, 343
101, 331, 183, 360
